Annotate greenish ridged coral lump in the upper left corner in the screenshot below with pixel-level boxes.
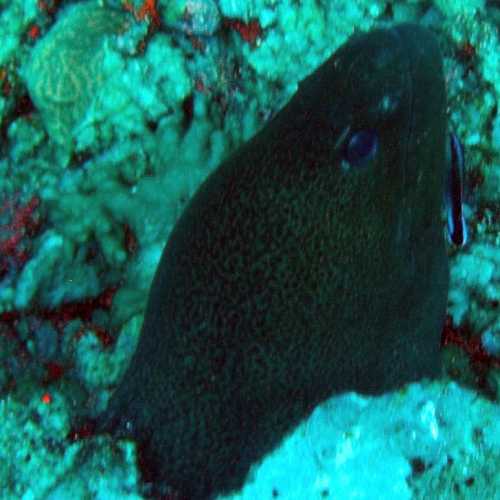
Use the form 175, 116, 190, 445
25, 2, 130, 146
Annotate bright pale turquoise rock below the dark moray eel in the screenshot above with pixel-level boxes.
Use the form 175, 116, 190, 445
219, 382, 500, 500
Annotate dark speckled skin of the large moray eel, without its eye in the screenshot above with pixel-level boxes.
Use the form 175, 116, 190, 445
102, 25, 448, 499
